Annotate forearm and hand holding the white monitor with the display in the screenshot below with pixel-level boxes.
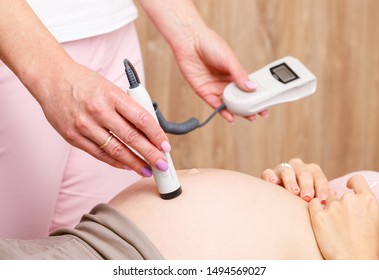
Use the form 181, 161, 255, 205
138, 0, 268, 122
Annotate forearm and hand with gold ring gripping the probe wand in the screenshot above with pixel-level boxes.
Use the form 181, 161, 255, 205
0, 1, 170, 176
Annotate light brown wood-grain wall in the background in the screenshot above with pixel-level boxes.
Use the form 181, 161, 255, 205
137, 0, 379, 178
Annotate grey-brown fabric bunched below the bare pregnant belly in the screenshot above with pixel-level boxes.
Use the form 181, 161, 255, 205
0, 204, 163, 260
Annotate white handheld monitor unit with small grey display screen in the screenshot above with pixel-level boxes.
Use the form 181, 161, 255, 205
223, 56, 317, 116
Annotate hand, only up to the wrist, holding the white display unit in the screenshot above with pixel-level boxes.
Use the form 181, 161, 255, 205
173, 26, 268, 122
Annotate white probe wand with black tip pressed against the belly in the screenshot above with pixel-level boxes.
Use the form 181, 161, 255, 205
124, 60, 182, 199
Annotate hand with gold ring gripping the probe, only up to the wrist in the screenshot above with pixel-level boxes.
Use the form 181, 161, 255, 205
29, 61, 170, 177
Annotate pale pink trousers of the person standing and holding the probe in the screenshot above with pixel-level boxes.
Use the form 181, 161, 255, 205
0, 24, 143, 239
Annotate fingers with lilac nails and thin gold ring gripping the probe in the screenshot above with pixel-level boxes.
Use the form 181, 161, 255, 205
90, 87, 171, 176
